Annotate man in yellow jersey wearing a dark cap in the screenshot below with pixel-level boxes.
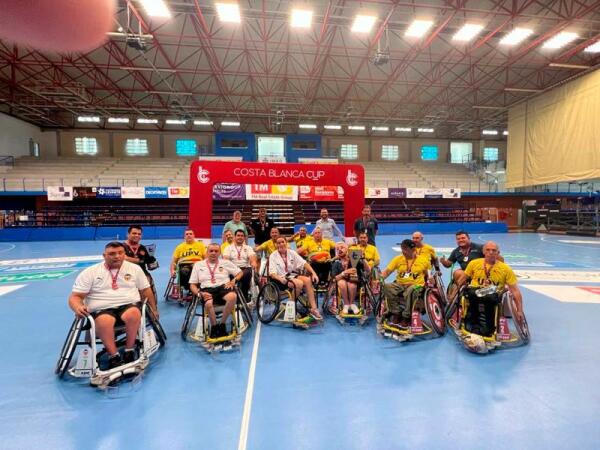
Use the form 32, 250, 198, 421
381, 239, 431, 327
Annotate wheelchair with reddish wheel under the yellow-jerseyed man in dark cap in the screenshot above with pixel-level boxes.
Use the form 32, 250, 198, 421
377, 271, 446, 342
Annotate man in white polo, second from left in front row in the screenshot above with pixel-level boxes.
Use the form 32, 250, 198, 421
190, 243, 242, 338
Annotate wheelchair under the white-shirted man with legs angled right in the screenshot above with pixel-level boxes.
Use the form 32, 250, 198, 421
256, 280, 320, 330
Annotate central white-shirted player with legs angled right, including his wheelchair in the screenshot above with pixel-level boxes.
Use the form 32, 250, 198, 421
256, 237, 322, 329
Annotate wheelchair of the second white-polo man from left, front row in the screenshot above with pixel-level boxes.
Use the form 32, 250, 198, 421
181, 283, 254, 353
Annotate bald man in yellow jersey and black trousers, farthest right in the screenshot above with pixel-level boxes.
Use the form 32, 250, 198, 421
465, 241, 523, 336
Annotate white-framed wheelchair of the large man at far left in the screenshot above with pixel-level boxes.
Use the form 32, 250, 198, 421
54, 303, 167, 389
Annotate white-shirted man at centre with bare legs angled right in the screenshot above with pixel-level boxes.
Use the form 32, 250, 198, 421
269, 237, 323, 320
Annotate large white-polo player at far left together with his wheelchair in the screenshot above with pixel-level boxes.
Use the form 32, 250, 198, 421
55, 241, 166, 388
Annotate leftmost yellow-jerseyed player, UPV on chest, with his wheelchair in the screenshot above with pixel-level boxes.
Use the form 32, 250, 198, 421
164, 229, 206, 306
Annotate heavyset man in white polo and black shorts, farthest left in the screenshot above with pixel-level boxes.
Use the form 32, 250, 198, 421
69, 241, 158, 369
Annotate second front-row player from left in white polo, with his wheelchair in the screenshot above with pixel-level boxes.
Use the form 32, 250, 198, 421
181, 243, 252, 351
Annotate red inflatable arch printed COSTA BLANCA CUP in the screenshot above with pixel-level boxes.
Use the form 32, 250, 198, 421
189, 161, 365, 239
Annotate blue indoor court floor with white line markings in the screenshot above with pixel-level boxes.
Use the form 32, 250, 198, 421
0, 234, 600, 450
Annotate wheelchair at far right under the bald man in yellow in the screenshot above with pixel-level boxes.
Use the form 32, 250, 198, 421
446, 286, 530, 354
